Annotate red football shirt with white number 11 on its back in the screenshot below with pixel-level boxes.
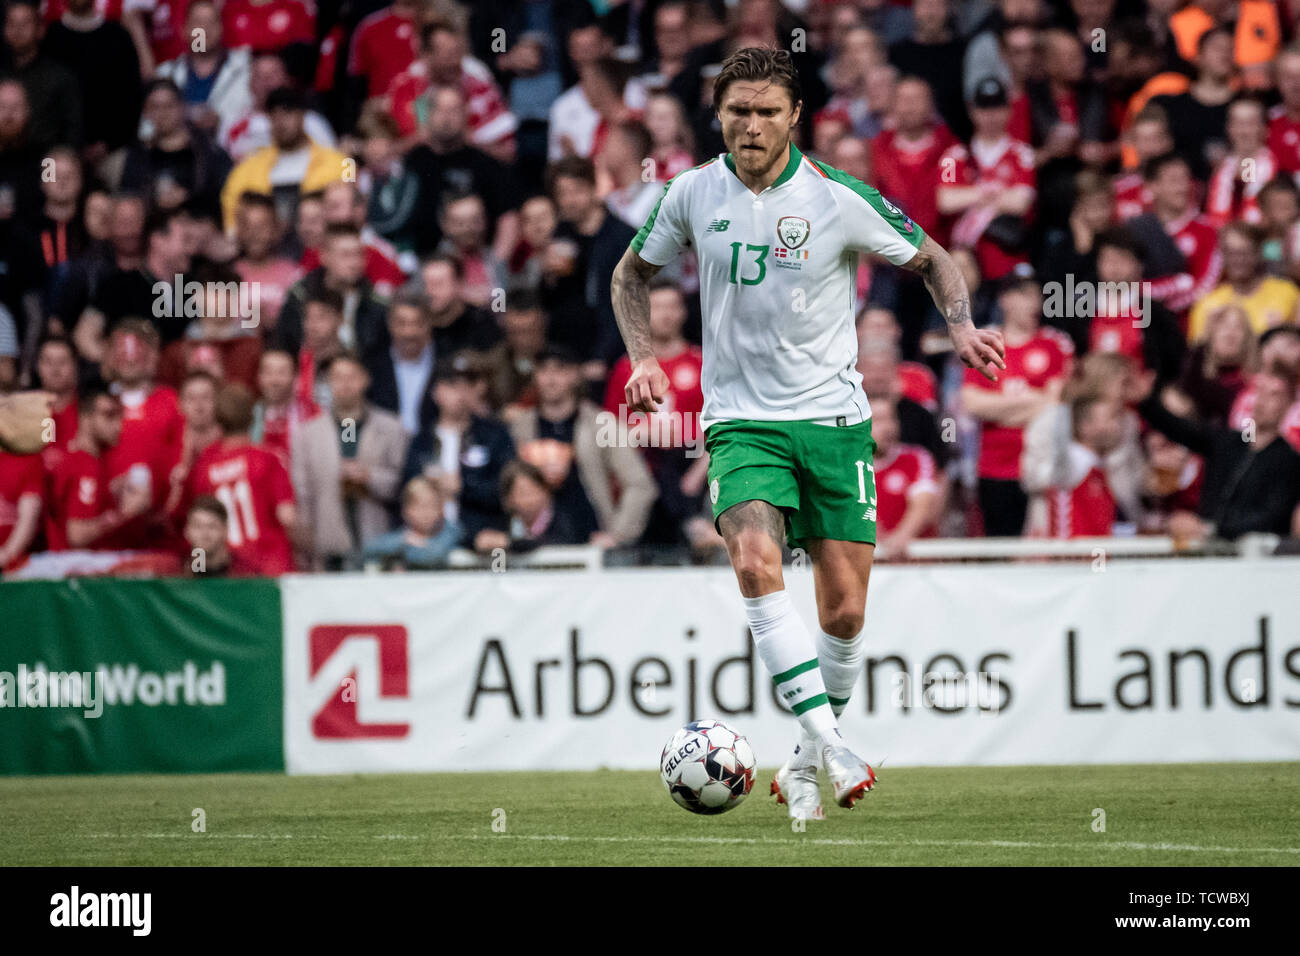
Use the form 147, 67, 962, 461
185, 440, 294, 575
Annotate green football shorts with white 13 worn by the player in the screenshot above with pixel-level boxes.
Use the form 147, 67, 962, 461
705, 419, 876, 548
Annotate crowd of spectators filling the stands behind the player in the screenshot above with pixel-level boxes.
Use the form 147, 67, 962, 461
0, 0, 1300, 575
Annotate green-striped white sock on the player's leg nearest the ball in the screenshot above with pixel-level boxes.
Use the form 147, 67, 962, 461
745, 591, 840, 752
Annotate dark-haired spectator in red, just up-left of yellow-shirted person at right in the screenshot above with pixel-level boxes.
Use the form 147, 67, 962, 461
1127, 153, 1223, 321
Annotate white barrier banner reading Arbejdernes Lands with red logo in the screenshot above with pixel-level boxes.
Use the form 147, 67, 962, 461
282, 558, 1300, 773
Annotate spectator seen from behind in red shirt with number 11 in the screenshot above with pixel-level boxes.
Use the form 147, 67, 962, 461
182, 385, 296, 576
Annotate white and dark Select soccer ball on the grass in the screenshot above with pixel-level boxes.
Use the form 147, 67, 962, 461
659, 721, 755, 813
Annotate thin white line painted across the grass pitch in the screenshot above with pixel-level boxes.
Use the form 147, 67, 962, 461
83, 832, 1300, 855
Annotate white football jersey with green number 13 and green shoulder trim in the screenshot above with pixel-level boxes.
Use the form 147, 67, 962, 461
632, 143, 926, 428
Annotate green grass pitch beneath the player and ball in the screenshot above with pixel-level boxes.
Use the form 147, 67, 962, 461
0, 763, 1300, 866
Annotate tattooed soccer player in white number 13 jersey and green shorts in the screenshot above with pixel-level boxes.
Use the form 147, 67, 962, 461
611, 47, 1002, 819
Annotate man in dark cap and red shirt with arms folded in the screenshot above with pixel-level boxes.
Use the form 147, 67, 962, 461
937, 77, 1037, 280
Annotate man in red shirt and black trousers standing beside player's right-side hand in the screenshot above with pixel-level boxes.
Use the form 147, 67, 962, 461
962, 274, 1074, 537
